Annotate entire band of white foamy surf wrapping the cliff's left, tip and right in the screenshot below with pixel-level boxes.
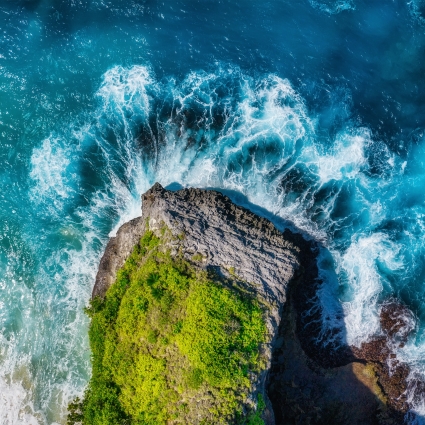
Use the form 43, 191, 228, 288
0, 65, 424, 423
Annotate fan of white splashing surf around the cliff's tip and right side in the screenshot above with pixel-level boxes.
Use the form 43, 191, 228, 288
21, 66, 423, 420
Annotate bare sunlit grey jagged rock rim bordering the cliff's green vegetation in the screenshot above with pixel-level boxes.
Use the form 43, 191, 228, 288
92, 183, 302, 424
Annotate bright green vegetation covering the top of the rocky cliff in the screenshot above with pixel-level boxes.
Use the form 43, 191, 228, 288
68, 231, 267, 425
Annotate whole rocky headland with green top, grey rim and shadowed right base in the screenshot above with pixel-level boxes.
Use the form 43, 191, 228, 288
68, 183, 407, 425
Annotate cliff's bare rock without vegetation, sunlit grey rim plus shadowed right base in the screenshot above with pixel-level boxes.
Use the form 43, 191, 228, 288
92, 183, 406, 425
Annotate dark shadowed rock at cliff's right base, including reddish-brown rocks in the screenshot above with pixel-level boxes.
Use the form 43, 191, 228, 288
268, 235, 425, 425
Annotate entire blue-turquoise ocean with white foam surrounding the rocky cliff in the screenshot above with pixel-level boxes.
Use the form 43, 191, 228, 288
0, 0, 425, 425
